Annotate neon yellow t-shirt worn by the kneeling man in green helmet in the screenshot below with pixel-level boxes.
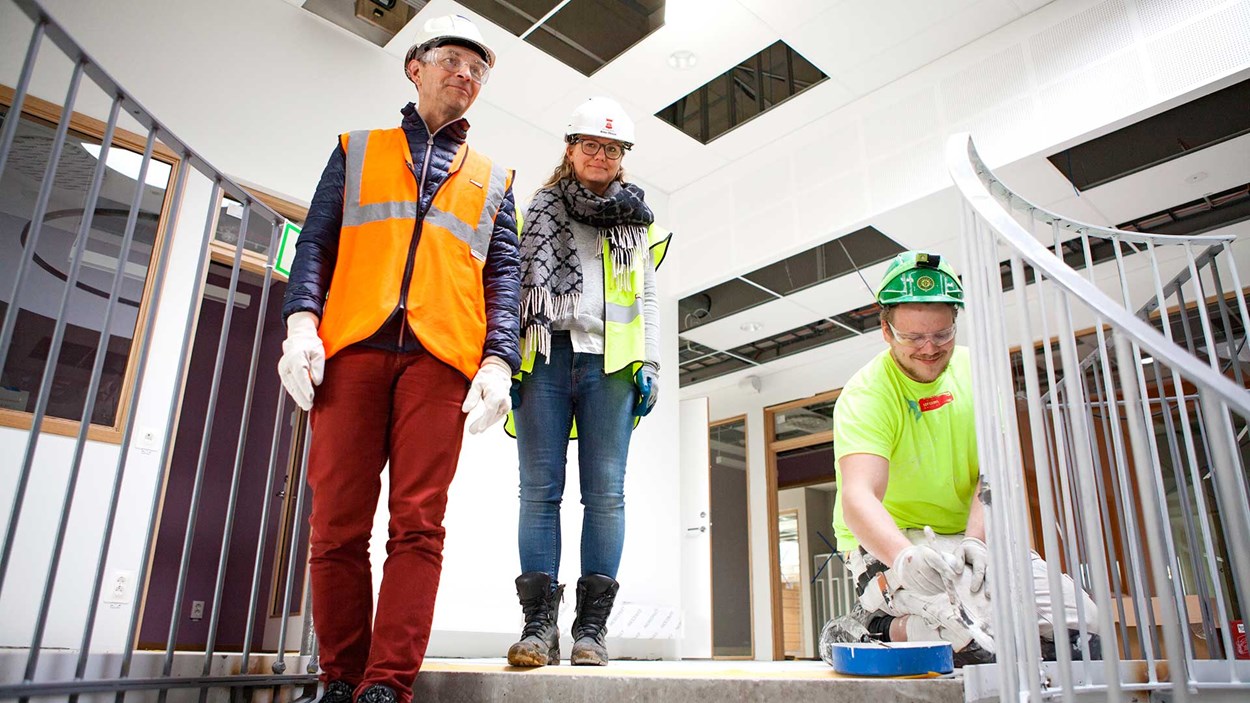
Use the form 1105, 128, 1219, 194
834, 346, 980, 552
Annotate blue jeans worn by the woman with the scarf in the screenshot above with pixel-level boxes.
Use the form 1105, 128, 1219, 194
515, 333, 638, 585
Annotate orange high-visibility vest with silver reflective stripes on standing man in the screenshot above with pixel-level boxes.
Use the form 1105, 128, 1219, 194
318, 128, 513, 378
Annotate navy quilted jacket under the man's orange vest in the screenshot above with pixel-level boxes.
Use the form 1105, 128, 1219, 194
283, 103, 521, 373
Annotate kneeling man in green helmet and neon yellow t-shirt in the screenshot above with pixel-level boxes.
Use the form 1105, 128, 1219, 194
821, 251, 1098, 665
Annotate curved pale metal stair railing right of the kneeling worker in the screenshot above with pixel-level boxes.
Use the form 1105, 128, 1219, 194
946, 134, 1250, 702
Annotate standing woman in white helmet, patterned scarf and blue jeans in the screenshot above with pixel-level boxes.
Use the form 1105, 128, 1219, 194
508, 98, 669, 667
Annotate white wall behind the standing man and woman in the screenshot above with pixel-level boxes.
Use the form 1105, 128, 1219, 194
0, 0, 681, 657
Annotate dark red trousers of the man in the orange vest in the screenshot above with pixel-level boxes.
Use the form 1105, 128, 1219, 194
309, 346, 469, 703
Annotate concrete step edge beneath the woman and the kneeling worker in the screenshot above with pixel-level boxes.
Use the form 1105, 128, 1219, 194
413, 659, 964, 703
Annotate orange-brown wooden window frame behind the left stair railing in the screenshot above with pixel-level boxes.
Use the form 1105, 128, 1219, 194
0, 85, 183, 444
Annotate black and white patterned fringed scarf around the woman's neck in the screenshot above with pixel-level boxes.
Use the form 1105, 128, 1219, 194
521, 178, 655, 357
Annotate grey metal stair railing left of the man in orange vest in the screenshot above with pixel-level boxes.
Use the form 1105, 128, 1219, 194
0, 0, 316, 703
